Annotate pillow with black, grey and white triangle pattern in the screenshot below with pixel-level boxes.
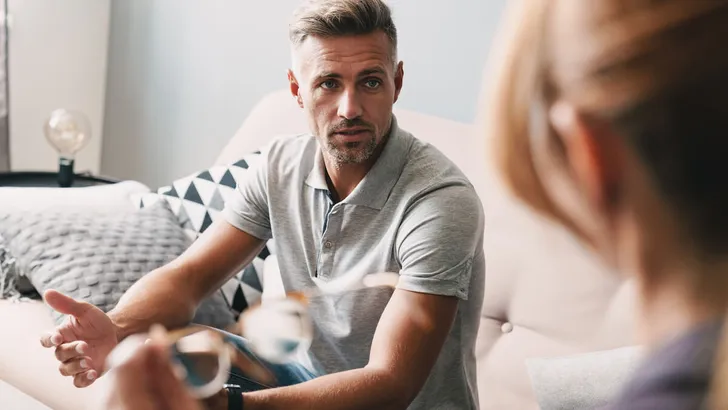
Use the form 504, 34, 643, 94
133, 151, 273, 315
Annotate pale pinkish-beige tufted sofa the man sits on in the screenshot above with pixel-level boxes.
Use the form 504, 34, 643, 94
0, 91, 634, 410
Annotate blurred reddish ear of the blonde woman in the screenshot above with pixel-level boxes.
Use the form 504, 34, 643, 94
549, 102, 624, 210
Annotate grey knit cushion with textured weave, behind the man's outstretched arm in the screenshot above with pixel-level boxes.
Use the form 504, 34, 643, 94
0, 203, 234, 328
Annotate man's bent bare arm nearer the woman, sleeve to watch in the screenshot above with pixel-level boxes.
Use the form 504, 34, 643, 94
243, 289, 458, 410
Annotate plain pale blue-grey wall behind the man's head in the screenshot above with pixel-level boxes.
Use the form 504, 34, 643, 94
102, 0, 506, 187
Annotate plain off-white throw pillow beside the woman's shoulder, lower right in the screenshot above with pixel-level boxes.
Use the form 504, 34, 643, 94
526, 346, 643, 410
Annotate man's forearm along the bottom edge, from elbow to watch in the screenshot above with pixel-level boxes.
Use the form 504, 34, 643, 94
243, 368, 413, 410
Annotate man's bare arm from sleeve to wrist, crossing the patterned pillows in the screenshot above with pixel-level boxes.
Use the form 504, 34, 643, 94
109, 218, 265, 340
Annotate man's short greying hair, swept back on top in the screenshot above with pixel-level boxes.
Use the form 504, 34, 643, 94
288, 0, 397, 64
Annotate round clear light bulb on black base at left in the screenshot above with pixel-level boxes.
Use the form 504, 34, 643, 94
43, 109, 91, 187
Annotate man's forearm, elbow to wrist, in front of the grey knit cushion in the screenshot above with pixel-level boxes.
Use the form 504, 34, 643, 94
109, 267, 196, 341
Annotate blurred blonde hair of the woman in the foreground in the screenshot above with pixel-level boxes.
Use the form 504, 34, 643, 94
484, 0, 728, 409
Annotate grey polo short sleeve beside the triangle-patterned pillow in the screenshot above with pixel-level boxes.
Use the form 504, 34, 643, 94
223, 147, 272, 241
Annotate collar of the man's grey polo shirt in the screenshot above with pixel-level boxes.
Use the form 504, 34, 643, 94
306, 115, 413, 209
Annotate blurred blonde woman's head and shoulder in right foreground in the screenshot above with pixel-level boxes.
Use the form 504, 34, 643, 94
486, 0, 728, 410
